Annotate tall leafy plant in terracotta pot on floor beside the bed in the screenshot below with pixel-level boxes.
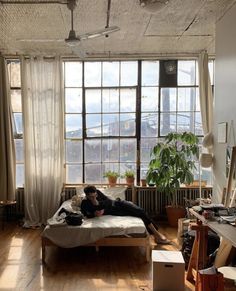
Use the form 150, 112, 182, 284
147, 132, 199, 226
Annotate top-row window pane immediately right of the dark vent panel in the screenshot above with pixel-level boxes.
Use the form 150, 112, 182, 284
178, 61, 196, 86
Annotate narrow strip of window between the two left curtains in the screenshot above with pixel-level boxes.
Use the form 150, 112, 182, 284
7, 60, 24, 187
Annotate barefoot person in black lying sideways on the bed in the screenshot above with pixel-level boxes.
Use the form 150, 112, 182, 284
81, 185, 171, 244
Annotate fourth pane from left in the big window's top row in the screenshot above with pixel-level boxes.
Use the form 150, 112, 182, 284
120, 62, 138, 86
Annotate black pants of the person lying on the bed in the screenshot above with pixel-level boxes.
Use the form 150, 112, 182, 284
106, 200, 153, 233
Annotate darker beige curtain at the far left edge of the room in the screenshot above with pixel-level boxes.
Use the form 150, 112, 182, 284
0, 56, 16, 201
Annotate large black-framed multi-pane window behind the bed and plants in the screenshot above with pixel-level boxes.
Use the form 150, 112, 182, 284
64, 60, 213, 183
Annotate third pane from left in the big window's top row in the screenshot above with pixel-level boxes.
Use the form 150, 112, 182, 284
102, 62, 119, 87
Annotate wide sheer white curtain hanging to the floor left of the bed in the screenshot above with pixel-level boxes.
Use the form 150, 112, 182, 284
21, 57, 64, 227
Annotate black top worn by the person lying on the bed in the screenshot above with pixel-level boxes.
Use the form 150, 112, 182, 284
81, 190, 113, 218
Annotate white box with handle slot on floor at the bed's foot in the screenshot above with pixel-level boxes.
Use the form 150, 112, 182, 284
152, 250, 185, 291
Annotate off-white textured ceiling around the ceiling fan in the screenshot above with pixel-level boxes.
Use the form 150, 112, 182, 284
0, 0, 236, 57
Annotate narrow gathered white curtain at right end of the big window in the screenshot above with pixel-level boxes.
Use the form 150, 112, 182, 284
198, 51, 213, 135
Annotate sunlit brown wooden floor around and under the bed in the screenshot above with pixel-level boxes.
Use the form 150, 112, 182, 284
0, 223, 195, 291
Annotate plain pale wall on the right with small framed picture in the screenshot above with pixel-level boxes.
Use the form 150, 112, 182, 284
213, 5, 236, 202
